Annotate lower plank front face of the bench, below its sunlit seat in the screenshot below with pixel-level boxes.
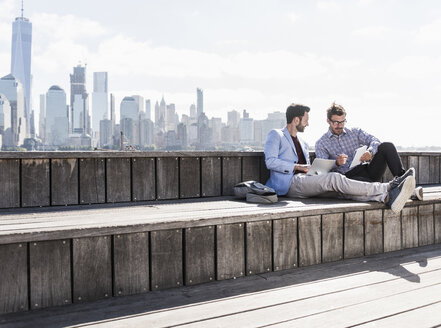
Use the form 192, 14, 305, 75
0, 201, 441, 313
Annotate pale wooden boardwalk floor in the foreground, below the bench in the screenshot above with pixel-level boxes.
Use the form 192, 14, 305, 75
0, 244, 441, 328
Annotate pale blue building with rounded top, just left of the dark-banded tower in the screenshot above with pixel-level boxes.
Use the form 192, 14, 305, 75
44, 85, 69, 146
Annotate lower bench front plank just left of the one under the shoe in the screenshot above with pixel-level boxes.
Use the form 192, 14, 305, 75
364, 210, 383, 255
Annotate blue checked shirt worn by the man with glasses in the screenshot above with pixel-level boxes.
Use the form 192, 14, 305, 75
315, 128, 381, 174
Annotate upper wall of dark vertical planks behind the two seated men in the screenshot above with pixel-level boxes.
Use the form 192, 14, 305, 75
0, 152, 441, 208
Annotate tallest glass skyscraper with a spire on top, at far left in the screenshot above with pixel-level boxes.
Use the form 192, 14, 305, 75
11, 2, 32, 136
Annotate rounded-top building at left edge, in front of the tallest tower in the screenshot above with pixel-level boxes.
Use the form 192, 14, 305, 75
0, 74, 26, 147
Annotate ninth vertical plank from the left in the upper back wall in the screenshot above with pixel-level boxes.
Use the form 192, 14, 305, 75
201, 157, 222, 197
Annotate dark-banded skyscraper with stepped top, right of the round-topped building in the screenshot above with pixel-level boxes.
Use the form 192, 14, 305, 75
70, 65, 89, 134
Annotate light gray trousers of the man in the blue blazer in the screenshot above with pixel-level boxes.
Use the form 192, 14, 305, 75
287, 172, 388, 202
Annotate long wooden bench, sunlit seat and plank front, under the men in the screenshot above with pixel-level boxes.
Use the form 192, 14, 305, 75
0, 190, 441, 313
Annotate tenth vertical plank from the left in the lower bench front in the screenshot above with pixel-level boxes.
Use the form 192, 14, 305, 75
298, 215, 322, 266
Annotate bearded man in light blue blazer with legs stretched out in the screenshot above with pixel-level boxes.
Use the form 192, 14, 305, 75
264, 104, 415, 213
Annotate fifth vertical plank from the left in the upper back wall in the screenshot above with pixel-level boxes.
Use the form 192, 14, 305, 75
106, 158, 131, 203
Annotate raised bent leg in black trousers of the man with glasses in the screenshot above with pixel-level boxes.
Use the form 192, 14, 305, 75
366, 142, 406, 181
